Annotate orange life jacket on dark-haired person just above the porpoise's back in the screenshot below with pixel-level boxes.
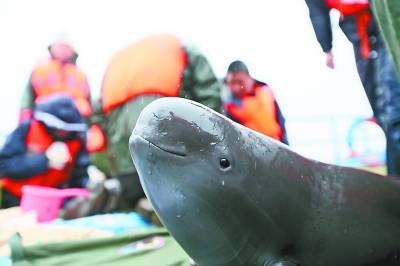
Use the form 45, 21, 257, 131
225, 85, 283, 141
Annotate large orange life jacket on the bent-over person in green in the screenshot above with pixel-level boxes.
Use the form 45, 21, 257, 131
101, 35, 186, 112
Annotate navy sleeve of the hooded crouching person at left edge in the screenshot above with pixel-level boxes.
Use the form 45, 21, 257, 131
0, 121, 48, 179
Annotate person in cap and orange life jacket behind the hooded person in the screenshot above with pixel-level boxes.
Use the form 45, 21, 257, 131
20, 39, 92, 122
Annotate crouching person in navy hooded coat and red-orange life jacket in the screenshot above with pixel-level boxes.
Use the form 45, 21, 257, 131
0, 94, 90, 207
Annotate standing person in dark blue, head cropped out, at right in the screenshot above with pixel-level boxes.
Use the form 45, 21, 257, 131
305, 0, 400, 175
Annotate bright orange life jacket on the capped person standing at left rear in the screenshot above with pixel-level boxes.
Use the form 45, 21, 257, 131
31, 60, 92, 117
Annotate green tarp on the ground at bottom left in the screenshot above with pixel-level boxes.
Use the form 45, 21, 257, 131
10, 229, 191, 266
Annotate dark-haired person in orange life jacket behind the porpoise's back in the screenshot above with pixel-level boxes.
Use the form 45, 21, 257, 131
224, 61, 288, 144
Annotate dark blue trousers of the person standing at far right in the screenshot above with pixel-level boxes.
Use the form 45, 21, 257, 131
340, 17, 400, 176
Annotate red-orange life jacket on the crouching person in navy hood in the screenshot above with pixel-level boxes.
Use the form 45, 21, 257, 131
2, 120, 81, 197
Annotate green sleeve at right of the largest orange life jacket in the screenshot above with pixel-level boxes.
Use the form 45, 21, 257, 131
180, 47, 222, 112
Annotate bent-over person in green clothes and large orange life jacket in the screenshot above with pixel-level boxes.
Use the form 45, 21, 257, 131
91, 34, 222, 208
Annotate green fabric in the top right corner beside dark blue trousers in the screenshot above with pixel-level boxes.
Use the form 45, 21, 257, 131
370, 0, 400, 75
